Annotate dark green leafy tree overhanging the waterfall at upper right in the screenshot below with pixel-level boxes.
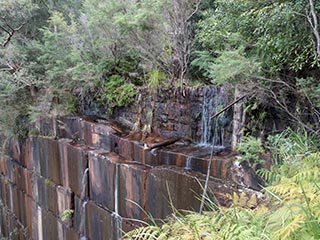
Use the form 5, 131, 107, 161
191, 0, 320, 132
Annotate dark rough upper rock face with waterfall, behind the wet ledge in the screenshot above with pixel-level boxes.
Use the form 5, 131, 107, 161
114, 86, 232, 146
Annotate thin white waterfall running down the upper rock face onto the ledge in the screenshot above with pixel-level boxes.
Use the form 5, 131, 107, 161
200, 87, 226, 147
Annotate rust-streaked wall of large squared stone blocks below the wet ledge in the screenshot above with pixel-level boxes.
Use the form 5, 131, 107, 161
0, 117, 244, 240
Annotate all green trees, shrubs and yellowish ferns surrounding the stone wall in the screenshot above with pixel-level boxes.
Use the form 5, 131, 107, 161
0, 0, 320, 239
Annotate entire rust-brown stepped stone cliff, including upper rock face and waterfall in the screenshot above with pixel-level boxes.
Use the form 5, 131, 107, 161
0, 85, 255, 240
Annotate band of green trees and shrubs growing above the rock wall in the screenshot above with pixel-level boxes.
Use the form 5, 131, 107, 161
0, 0, 320, 138
